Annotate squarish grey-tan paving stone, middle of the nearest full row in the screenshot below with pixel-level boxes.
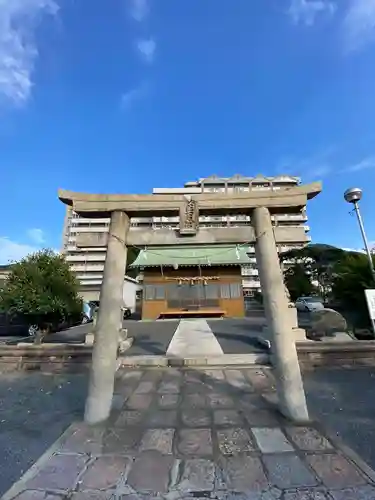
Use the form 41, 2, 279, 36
176, 458, 215, 497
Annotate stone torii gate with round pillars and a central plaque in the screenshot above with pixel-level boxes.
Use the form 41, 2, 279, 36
59, 183, 321, 424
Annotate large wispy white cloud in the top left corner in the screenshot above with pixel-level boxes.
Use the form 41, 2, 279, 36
0, 0, 58, 105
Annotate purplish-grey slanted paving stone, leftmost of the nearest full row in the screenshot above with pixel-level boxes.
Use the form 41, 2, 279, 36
26, 455, 87, 490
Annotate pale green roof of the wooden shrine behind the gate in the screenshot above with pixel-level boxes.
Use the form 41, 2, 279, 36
131, 245, 251, 267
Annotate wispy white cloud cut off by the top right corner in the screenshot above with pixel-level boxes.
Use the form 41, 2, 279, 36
343, 0, 375, 52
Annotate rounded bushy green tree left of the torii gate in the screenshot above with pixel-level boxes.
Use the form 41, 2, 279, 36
0, 250, 82, 343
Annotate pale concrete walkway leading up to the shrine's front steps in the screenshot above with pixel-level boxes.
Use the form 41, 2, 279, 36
167, 319, 223, 358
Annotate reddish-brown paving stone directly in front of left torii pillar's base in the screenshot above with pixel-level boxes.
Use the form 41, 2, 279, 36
59, 424, 104, 455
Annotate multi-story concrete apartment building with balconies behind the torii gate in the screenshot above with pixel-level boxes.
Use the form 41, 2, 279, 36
63, 175, 310, 296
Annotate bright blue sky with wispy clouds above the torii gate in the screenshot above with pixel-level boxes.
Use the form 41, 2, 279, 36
0, 0, 375, 263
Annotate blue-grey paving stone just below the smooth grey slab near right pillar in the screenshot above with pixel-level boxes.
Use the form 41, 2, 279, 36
263, 453, 317, 489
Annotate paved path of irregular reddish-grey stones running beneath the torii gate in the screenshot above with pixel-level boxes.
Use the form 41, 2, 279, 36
3, 367, 375, 500
